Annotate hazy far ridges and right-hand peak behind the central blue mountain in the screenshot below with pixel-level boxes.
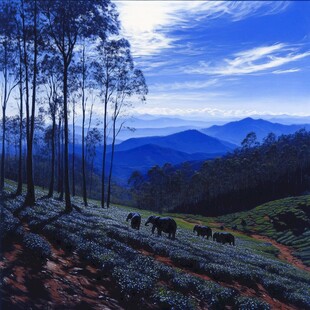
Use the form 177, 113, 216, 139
70, 115, 310, 145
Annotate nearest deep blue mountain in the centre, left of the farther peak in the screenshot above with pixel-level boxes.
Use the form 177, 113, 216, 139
87, 130, 236, 183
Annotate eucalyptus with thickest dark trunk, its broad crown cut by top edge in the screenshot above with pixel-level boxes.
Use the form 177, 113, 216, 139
42, 0, 119, 212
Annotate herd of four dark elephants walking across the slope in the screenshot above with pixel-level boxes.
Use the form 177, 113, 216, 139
126, 212, 235, 245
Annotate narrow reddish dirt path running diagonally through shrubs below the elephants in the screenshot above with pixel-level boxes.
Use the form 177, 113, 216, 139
139, 249, 298, 310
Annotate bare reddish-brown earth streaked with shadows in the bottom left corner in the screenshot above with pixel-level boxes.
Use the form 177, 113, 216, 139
0, 243, 123, 310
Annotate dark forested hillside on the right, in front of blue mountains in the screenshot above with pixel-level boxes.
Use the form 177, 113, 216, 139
130, 130, 310, 215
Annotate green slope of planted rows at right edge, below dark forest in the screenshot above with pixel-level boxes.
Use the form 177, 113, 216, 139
218, 195, 310, 266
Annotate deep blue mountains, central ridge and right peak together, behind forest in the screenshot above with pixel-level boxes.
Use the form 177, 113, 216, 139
58, 118, 310, 185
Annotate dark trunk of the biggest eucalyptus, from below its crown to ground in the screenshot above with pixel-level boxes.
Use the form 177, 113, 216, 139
63, 59, 72, 212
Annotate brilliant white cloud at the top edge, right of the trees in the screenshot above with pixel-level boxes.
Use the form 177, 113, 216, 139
116, 0, 289, 56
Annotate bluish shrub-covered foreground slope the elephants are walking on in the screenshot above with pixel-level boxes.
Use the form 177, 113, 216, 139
5, 183, 310, 309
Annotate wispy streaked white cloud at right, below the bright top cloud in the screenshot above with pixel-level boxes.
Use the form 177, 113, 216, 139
184, 43, 310, 76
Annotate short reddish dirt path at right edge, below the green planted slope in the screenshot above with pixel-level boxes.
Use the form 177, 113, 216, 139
250, 234, 310, 272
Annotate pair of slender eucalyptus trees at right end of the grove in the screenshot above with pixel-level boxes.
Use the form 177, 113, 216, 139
93, 39, 147, 207
